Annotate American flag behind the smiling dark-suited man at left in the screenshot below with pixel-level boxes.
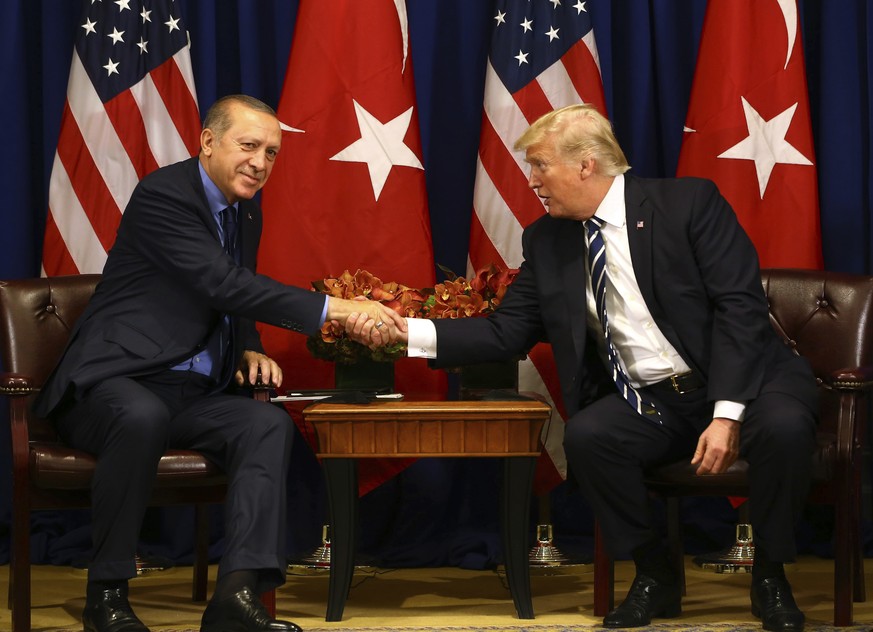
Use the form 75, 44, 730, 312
42, 0, 200, 276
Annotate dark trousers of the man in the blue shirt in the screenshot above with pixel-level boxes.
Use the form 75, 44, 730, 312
57, 371, 293, 591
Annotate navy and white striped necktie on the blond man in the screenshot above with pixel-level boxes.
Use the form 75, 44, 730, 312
585, 217, 660, 423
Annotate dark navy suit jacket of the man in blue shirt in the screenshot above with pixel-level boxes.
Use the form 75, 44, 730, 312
35, 158, 324, 416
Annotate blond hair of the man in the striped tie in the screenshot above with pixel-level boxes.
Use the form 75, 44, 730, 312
514, 103, 630, 176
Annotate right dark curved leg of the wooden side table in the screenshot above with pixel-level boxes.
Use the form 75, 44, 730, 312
502, 456, 537, 619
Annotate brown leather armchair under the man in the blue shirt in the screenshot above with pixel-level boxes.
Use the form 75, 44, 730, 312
0, 274, 275, 632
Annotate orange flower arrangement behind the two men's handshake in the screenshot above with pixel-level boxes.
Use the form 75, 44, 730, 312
306, 264, 518, 364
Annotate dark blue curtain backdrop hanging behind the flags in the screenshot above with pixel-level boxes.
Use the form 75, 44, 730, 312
0, 0, 873, 567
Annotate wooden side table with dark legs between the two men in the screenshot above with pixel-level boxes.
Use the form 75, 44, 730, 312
303, 399, 551, 621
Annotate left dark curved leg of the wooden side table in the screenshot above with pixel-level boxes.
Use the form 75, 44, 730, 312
322, 459, 358, 621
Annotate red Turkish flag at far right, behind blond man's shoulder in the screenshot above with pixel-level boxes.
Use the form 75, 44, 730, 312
676, 0, 822, 268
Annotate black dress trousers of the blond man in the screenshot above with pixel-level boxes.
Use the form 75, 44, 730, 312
564, 376, 816, 562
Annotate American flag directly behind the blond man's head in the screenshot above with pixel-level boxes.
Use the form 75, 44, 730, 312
469, 0, 606, 492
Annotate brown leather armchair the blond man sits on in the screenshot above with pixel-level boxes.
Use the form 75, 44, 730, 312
594, 269, 873, 626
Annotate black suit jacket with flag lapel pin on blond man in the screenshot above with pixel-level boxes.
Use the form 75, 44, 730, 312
434, 175, 814, 415
